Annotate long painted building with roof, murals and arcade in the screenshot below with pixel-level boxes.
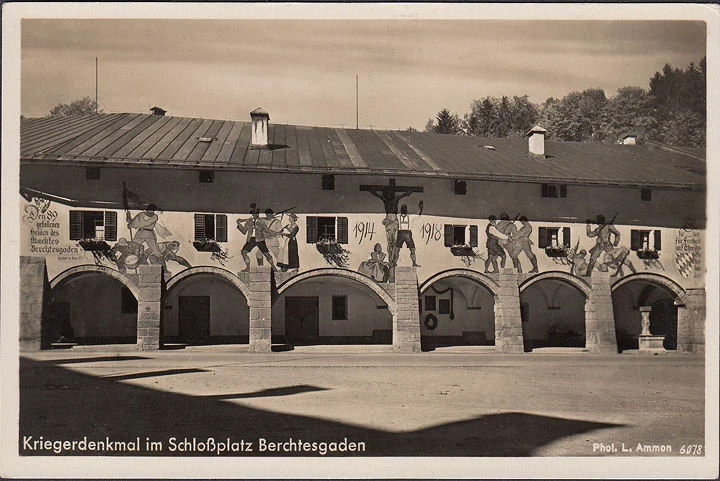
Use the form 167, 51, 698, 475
20, 109, 706, 352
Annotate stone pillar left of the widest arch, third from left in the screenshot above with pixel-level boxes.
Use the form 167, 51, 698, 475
247, 266, 272, 352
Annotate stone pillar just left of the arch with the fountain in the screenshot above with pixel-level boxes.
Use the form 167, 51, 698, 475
585, 271, 618, 353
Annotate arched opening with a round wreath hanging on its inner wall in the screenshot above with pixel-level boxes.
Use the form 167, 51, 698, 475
420, 272, 497, 350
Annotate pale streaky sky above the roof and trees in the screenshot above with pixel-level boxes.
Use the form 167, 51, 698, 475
21, 20, 706, 129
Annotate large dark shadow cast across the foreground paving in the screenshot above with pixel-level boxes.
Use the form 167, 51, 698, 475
19, 358, 620, 456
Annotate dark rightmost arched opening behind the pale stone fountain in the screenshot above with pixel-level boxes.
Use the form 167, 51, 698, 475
612, 275, 684, 351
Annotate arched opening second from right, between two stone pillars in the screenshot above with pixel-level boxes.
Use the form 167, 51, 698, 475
520, 276, 586, 351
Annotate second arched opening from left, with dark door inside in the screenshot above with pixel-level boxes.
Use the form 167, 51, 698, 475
165, 271, 250, 345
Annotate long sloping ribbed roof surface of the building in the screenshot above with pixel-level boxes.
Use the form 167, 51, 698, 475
20, 113, 706, 189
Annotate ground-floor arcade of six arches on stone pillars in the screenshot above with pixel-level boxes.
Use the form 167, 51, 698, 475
21, 257, 704, 353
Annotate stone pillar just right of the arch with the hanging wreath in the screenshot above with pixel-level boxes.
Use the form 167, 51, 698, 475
495, 269, 525, 352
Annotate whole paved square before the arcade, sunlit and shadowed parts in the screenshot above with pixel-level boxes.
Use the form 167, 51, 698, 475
20, 346, 705, 456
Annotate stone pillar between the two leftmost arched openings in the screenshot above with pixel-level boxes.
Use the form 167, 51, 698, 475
137, 265, 163, 351
